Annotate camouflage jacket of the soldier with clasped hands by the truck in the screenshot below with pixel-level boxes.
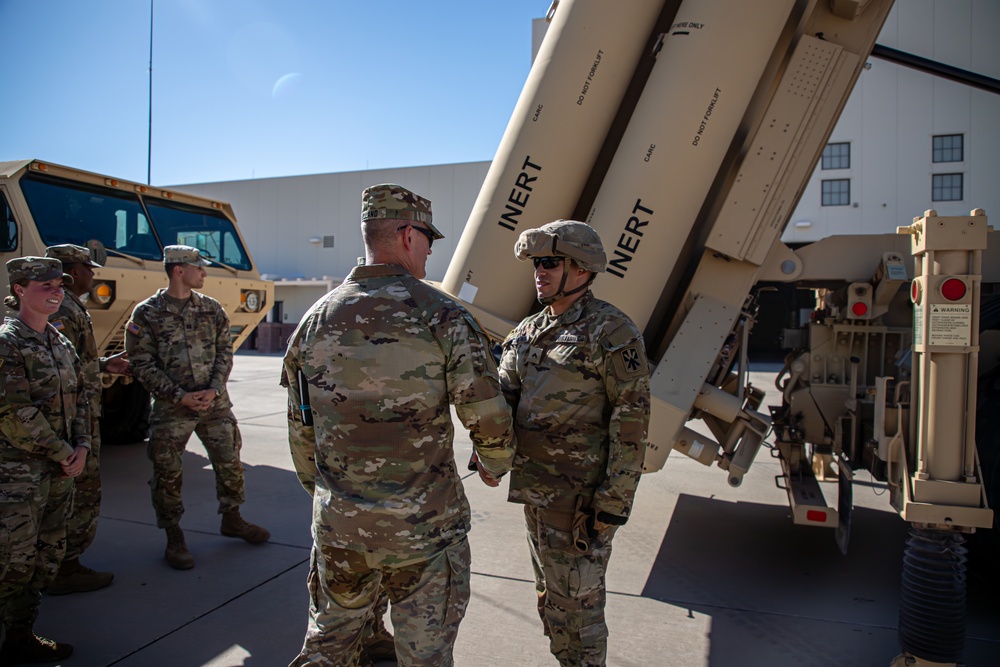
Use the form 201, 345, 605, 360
125, 289, 233, 405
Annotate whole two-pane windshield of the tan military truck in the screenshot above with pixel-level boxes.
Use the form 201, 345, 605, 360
21, 173, 252, 271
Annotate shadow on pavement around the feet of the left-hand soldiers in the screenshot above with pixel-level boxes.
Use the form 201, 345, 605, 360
37, 438, 311, 667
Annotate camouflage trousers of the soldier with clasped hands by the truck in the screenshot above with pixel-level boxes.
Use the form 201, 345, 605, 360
146, 401, 244, 528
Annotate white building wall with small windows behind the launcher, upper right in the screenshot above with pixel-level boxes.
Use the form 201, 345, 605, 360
782, 0, 1000, 243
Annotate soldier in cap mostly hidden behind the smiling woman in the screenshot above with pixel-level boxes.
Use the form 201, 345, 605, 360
45, 243, 130, 595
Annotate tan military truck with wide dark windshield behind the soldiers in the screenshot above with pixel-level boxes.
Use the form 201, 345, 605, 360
0, 160, 274, 442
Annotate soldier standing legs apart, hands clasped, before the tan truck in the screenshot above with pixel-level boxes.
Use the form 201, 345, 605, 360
125, 245, 271, 570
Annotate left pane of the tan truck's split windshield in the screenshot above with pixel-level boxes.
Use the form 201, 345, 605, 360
21, 174, 163, 260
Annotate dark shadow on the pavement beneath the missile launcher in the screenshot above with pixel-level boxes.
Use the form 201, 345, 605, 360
642, 494, 1000, 667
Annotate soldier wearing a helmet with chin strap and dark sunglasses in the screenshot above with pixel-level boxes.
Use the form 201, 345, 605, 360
500, 220, 649, 667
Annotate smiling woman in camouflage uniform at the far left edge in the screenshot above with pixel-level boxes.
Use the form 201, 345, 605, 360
0, 257, 90, 665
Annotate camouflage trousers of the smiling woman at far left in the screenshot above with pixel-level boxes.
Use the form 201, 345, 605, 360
0, 449, 73, 628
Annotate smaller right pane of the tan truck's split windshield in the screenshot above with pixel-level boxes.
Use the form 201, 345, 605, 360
146, 199, 251, 271
